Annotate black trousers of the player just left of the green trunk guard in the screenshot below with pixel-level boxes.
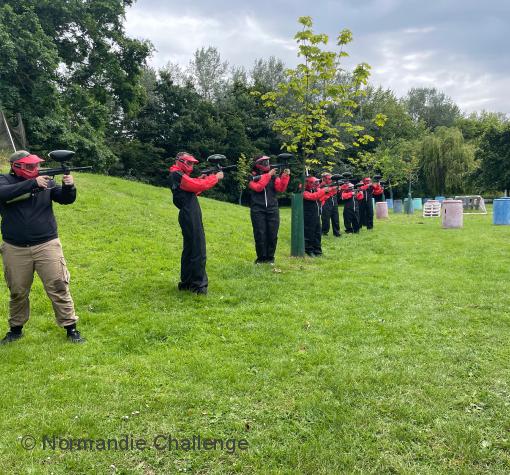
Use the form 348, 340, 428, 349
250, 208, 280, 262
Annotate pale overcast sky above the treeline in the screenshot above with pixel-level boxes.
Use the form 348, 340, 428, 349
126, 0, 510, 113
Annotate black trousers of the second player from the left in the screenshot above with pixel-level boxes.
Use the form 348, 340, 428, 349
179, 206, 208, 291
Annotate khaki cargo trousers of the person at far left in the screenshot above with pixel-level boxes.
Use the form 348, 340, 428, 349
0, 238, 78, 327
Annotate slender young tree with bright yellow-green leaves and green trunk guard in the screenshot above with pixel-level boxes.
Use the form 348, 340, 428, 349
262, 17, 384, 256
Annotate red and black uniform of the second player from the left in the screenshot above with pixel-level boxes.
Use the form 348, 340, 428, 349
170, 164, 218, 293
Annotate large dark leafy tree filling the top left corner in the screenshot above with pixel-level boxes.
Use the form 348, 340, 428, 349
0, 0, 151, 170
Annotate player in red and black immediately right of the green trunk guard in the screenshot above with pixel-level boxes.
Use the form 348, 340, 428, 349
303, 177, 326, 257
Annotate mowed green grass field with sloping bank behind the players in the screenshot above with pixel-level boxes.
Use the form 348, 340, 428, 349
0, 175, 510, 474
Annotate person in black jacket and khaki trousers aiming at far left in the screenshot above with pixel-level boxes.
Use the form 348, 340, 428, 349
0, 150, 85, 344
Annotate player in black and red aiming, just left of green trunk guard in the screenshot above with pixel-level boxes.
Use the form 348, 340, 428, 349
248, 155, 290, 264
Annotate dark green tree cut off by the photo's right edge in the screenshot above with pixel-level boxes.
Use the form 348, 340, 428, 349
476, 124, 510, 195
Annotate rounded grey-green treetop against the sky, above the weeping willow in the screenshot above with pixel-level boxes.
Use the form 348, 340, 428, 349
404, 88, 460, 130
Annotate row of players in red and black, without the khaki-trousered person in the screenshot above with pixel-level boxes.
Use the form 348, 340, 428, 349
169, 152, 384, 295
